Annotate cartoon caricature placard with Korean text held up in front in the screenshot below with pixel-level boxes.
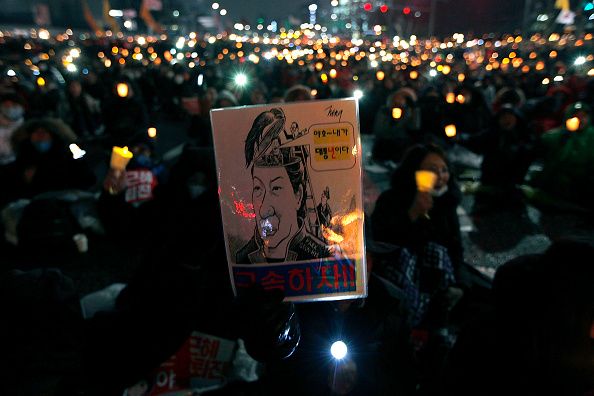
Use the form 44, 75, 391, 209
211, 99, 366, 301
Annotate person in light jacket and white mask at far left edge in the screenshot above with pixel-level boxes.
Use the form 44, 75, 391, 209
0, 94, 25, 165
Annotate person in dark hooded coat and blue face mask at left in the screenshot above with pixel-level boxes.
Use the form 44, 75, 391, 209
0, 118, 95, 205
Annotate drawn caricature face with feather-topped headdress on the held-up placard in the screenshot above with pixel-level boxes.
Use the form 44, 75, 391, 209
236, 108, 330, 264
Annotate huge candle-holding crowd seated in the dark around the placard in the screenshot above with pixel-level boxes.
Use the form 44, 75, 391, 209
0, 26, 594, 395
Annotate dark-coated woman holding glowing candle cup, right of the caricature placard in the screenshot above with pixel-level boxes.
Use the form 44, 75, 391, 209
371, 144, 463, 325
